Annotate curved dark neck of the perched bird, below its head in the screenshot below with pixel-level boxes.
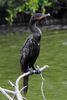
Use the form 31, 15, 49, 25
30, 24, 42, 43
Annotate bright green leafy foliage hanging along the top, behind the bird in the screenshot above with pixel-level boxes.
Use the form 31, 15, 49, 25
0, 0, 51, 25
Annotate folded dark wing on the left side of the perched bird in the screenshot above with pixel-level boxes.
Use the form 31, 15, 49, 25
20, 35, 31, 69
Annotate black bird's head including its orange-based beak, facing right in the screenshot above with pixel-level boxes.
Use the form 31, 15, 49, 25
30, 13, 50, 24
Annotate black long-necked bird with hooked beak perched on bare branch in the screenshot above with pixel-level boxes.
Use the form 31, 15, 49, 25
20, 13, 49, 94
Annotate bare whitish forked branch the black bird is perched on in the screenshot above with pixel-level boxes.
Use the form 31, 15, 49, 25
0, 65, 48, 100
